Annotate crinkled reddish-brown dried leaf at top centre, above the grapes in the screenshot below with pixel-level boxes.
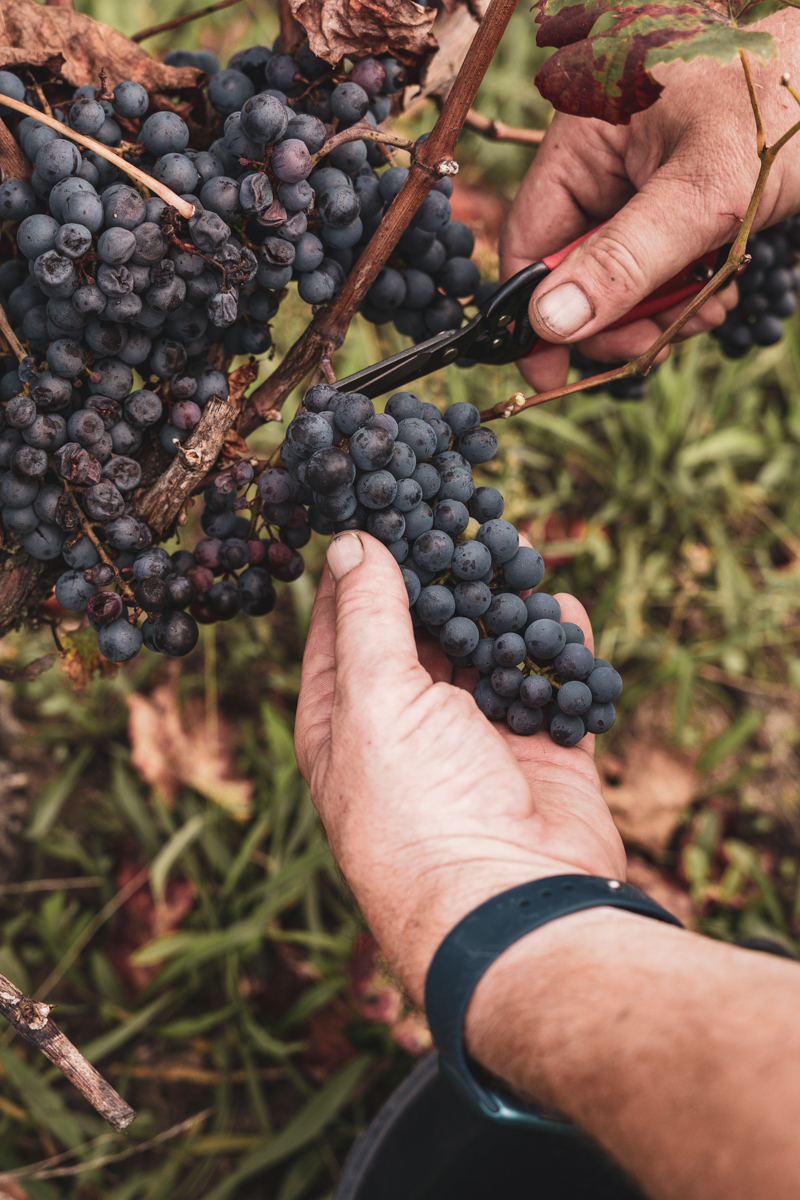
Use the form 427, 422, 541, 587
290, 0, 437, 65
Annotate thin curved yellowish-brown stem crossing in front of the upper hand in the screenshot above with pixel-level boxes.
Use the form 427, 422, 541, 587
481, 50, 800, 421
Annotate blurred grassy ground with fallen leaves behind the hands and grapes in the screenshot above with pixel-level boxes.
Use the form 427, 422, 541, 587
0, 0, 800, 1200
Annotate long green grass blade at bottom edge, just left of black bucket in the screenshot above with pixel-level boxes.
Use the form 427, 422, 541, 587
204, 1055, 372, 1200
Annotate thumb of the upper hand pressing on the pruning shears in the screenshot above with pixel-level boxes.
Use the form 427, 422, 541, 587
530, 162, 733, 342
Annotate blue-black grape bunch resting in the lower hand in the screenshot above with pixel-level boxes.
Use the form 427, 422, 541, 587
278, 384, 622, 746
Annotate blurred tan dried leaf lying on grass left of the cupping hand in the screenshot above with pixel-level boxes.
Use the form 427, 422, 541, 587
128, 680, 253, 821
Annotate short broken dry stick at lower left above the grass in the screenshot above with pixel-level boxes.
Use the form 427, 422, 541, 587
0, 976, 136, 1132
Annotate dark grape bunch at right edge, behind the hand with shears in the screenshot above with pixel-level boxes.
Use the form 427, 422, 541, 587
711, 216, 800, 359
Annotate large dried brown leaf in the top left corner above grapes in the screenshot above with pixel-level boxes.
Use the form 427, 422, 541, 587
0, 0, 203, 91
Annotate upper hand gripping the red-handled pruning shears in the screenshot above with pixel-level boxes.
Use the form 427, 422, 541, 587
500, 11, 800, 391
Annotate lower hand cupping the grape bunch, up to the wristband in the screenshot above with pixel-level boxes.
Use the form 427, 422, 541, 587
295, 532, 625, 1002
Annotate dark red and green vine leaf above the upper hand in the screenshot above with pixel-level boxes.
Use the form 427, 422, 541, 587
536, 0, 777, 125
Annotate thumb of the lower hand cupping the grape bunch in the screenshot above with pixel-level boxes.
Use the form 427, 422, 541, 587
327, 530, 431, 707
